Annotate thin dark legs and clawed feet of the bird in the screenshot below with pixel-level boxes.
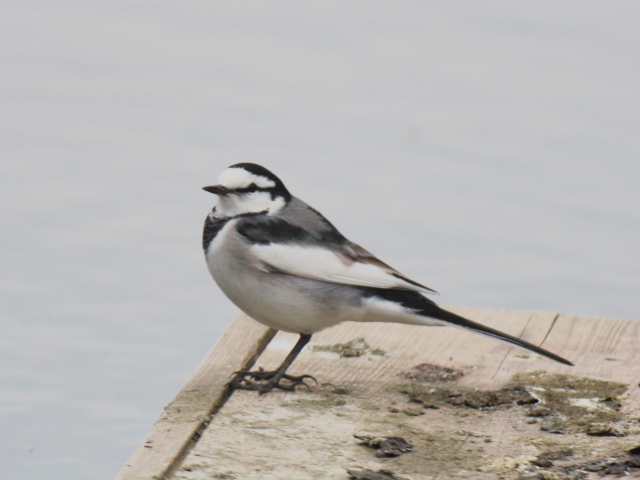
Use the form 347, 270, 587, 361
229, 333, 317, 395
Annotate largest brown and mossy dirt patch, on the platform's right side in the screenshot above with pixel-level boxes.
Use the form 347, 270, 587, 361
396, 365, 640, 480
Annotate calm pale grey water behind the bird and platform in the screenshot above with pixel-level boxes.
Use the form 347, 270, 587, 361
0, 0, 640, 480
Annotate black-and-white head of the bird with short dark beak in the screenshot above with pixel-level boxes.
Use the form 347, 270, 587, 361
203, 163, 291, 217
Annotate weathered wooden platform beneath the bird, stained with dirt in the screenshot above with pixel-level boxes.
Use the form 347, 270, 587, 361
120, 308, 640, 480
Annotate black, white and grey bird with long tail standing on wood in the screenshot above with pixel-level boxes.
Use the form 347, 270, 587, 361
202, 163, 573, 394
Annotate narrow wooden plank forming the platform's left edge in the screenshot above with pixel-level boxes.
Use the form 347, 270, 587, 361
117, 313, 276, 480
